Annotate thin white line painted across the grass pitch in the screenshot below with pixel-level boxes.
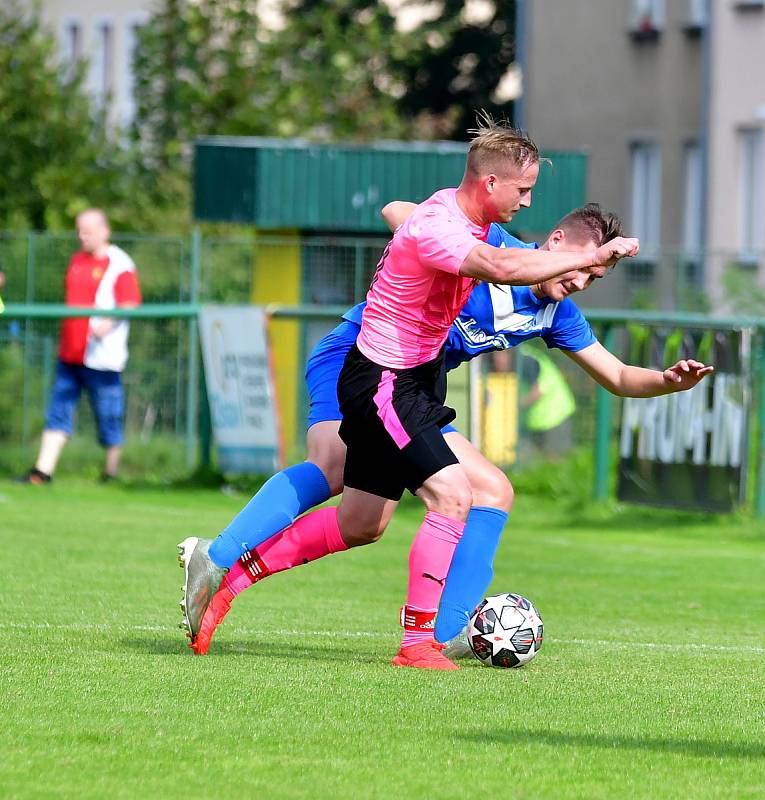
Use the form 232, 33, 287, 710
0, 622, 765, 654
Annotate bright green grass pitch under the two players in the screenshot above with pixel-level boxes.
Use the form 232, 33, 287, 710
0, 478, 765, 800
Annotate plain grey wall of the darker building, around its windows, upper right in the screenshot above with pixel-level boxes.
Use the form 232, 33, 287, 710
524, 0, 702, 306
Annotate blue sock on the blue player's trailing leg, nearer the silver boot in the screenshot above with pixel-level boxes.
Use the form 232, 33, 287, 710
209, 461, 331, 567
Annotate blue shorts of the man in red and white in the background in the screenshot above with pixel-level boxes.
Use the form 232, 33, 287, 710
45, 361, 125, 447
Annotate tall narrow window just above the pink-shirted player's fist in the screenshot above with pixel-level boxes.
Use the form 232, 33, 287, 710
630, 142, 661, 261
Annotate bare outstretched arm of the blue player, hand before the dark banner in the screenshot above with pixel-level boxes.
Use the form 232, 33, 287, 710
565, 342, 714, 397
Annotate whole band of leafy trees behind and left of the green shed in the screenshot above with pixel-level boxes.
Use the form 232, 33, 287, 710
0, 0, 514, 230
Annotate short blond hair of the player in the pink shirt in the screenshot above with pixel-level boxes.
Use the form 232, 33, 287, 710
465, 111, 549, 178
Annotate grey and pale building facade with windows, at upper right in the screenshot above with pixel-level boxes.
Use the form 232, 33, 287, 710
517, 0, 765, 308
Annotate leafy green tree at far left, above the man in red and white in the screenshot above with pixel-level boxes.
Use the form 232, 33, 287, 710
0, 0, 133, 229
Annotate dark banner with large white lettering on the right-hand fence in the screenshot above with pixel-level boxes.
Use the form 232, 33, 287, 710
618, 328, 751, 511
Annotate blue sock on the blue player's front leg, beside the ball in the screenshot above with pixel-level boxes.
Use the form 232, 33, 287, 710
436, 506, 508, 642
